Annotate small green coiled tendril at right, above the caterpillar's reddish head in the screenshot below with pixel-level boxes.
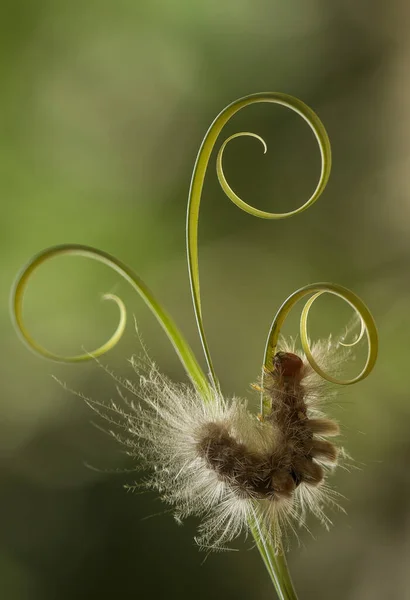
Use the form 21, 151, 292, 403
261, 283, 378, 416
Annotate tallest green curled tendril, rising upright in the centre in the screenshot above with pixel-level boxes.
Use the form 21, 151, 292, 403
187, 92, 332, 386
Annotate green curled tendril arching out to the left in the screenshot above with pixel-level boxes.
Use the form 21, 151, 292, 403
11, 244, 210, 397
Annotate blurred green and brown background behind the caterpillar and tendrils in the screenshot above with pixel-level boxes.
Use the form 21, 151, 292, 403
0, 0, 410, 600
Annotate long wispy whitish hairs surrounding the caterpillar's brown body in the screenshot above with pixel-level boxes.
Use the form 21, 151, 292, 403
85, 339, 346, 549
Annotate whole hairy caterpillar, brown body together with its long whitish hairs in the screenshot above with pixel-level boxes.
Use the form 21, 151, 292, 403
90, 340, 346, 549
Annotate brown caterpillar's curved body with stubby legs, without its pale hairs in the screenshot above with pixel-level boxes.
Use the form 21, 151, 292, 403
197, 352, 339, 500
